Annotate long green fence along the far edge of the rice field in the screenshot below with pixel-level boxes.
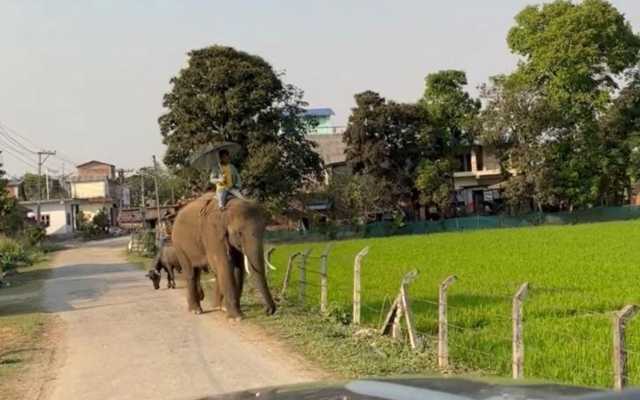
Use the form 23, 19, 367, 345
266, 206, 640, 241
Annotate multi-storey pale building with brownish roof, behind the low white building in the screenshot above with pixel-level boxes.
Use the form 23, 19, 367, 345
69, 160, 130, 225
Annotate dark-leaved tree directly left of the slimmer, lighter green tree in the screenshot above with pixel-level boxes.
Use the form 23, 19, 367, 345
343, 91, 425, 204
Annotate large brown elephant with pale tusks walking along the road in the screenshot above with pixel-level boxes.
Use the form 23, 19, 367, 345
171, 195, 276, 319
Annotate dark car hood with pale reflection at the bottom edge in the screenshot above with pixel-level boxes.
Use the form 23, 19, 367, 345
203, 378, 640, 400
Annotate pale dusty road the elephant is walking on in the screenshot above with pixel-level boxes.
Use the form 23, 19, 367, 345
38, 239, 319, 400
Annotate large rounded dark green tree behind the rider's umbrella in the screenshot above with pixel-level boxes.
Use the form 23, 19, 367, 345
159, 46, 322, 211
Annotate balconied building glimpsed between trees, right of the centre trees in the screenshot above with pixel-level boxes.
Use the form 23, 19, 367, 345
453, 144, 504, 213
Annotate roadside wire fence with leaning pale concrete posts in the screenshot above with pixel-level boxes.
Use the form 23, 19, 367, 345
272, 244, 640, 388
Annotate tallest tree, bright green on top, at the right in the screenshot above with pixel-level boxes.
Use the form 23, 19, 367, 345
483, 0, 640, 210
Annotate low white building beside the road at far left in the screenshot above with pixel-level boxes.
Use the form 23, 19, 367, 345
20, 199, 80, 235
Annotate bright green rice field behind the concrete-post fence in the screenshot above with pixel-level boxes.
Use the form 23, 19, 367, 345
271, 221, 640, 387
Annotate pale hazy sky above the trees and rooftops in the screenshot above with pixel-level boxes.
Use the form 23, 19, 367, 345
0, 0, 640, 176
